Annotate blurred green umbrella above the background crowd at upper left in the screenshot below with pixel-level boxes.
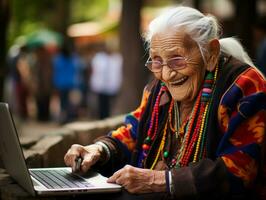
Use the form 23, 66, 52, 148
25, 29, 63, 49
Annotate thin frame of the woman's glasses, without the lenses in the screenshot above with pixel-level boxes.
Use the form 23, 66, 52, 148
145, 56, 188, 73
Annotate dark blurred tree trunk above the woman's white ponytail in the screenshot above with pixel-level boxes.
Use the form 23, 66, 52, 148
233, 0, 257, 57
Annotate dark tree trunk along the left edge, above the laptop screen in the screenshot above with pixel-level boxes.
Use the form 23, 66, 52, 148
0, 0, 10, 101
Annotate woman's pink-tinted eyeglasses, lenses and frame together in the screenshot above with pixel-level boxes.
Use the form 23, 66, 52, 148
145, 56, 188, 72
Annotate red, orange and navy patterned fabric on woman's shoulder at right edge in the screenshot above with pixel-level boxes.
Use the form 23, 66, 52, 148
218, 68, 266, 185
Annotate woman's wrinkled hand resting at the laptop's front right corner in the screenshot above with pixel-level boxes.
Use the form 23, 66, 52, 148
107, 165, 166, 194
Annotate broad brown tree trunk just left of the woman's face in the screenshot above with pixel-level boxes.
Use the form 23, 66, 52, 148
117, 0, 144, 113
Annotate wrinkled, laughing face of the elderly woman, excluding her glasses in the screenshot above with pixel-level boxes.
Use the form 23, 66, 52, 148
150, 31, 205, 102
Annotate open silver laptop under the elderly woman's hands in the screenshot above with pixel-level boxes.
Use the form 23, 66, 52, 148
0, 103, 121, 196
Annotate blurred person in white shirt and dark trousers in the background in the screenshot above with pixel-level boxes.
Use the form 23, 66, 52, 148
90, 45, 122, 119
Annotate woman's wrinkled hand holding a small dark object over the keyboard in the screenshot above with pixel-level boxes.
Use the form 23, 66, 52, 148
64, 144, 103, 173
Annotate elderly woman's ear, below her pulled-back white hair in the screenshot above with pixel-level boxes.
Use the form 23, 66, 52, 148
207, 39, 220, 72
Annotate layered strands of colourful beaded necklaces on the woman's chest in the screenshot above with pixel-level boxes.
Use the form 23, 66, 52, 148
145, 67, 218, 169
